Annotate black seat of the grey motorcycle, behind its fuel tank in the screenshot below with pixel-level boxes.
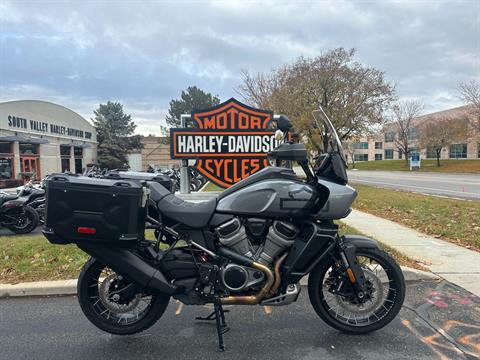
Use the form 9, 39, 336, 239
148, 183, 217, 228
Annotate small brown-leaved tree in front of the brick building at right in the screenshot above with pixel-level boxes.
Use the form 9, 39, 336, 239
419, 117, 468, 167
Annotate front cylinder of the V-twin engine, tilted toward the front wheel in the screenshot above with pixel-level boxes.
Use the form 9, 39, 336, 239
257, 220, 298, 265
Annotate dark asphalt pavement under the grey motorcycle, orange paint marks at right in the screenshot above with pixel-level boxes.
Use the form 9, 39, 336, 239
0, 281, 480, 360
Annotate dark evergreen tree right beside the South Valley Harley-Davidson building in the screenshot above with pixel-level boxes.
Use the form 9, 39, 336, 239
93, 101, 143, 169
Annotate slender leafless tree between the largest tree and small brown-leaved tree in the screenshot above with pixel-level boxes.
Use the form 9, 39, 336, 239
391, 100, 424, 164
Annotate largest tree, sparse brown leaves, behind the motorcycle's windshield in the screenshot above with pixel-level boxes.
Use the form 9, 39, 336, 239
237, 48, 395, 152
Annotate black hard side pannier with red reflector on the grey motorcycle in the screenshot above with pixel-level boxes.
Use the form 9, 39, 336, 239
43, 174, 145, 248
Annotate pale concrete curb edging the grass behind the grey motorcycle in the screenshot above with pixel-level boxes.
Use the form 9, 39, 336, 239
0, 267, 440, 299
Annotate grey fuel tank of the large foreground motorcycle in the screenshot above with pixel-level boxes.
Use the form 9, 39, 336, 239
217, 179, 317, 218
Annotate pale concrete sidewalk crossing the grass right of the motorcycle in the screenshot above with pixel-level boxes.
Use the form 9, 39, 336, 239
342, 210, 480, 296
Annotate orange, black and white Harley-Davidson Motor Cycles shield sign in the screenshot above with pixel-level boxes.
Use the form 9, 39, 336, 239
170, 98, 278, 188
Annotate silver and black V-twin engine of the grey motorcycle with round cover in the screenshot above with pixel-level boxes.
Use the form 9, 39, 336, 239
216, 218, 298, 291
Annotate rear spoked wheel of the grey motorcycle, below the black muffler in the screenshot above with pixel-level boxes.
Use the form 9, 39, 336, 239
77, 258, 170, 335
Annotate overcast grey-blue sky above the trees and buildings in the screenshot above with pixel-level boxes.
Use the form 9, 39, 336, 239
0, 0, 480, 134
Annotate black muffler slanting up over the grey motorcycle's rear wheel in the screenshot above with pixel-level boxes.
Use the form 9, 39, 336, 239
77, 244, 179, 295
